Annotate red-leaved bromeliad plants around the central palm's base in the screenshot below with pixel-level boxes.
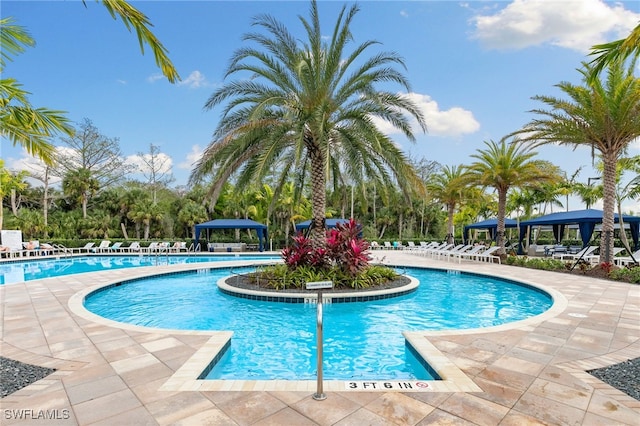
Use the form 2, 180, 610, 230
282, 219, 371, 276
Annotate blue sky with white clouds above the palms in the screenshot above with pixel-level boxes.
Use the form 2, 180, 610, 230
0, 0, 640, 209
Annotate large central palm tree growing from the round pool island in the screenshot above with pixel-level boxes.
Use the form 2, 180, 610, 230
190, 0, 426, 247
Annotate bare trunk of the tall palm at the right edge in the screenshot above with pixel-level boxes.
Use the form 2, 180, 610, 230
600, 152, 618, 263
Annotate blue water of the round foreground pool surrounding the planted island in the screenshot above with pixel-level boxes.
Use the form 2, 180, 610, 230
85, 268, 552, 380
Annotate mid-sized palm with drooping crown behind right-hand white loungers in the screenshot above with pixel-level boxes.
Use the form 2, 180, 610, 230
465, 137, 559, 254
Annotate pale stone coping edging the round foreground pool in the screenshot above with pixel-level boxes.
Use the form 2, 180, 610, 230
68, 260, 568, 392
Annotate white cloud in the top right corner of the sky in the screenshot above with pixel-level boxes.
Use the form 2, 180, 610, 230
472, 0, 640, 52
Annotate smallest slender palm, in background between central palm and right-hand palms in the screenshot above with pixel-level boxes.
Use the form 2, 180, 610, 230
427, 165, 467, 243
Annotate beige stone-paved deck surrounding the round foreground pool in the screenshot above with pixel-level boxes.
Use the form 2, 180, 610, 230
0, 250, 640, 426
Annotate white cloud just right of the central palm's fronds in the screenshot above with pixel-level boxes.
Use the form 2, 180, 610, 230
374, 93, 480, 137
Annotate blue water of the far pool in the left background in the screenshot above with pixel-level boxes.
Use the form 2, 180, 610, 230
0, 255, 281, 284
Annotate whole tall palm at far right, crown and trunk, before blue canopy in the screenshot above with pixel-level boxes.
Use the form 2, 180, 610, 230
515, 61, 640, 263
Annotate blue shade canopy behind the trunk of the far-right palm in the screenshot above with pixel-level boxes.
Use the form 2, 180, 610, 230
520, 209, 640, 249
